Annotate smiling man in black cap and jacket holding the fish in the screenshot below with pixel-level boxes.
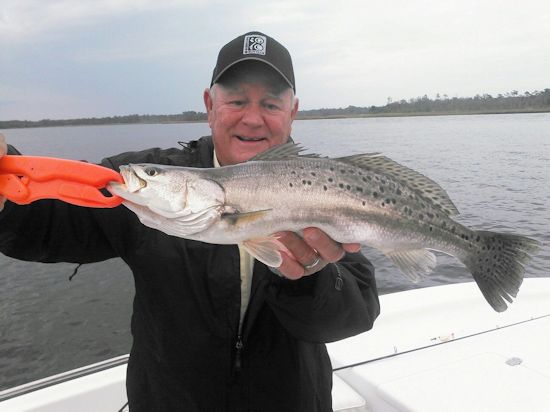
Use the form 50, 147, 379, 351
0, 32, 379, 412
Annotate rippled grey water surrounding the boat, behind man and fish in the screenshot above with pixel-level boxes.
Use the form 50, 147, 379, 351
0, 114, 550, 390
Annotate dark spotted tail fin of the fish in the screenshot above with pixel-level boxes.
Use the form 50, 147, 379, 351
463, 231, 541, 312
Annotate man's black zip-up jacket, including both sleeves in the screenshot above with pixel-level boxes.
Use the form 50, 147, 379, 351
0, 137, 379, 412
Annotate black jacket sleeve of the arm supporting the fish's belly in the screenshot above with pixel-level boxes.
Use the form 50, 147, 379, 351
267, 253, 380, 343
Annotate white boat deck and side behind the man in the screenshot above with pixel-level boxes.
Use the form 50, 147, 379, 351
0, 278, 550, 412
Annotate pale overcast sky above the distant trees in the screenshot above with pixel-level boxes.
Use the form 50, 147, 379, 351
0, 0, 550, 120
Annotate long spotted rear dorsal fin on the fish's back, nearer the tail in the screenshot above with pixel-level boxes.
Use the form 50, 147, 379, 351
334, 153, 459, 216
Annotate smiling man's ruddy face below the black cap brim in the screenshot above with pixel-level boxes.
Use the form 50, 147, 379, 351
204, 81, 298, 166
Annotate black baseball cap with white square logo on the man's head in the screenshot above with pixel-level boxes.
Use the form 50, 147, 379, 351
210, 31, 296, 93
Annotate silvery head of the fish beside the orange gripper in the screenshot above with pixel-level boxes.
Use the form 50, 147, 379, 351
107, 164, 225, 218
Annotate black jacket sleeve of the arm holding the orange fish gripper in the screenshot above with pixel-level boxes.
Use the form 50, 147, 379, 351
0, 147, 179, 263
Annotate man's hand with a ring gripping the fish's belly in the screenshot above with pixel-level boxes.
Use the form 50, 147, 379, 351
278, 227, 361, 279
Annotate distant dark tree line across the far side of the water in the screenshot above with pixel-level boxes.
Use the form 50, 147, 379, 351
0, 89, 550, 129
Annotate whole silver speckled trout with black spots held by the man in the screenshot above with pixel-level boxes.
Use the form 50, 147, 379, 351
109, 143, 539, 312
